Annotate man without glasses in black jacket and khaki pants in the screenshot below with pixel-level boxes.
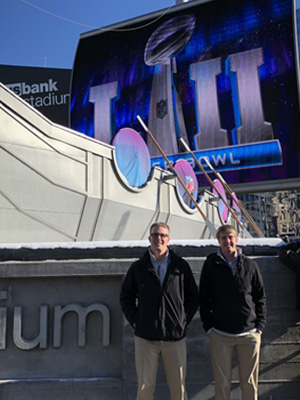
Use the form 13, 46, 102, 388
200, 225, 266, 400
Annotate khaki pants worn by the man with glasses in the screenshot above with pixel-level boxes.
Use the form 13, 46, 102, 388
134, 336, 187, 400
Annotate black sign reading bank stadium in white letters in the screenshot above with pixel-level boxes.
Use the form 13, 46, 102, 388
0, 65, 71, 127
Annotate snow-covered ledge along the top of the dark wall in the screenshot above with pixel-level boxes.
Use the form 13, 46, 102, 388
0, 238, 285, 261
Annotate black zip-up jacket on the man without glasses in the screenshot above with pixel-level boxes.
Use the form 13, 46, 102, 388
200, 253, 267, 334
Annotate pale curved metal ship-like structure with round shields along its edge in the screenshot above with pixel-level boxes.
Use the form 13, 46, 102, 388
0, 84, 248, 243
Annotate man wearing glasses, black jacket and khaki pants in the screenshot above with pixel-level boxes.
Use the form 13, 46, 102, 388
120, 222, 199, 400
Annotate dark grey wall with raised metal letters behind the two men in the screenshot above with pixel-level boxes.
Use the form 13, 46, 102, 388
0, 242, 300, 400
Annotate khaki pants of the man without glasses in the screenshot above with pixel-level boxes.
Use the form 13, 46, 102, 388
209, 331, 261, 400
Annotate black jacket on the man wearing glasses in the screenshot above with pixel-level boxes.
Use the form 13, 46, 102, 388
120, 250, 199, 341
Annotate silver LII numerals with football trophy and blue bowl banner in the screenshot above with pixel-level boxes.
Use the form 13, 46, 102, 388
85, 15, 282, 173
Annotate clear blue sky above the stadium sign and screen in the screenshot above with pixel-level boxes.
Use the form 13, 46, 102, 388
0, 0, 300, 68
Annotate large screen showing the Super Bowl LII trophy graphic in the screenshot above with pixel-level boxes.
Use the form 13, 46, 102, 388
71, 0, 300, 188
